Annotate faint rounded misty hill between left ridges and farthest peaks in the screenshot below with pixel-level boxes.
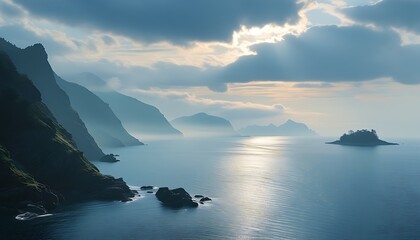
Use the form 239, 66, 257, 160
171, 113, 239, 137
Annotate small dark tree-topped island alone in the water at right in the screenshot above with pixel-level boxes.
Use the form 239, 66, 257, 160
327, 129, 398, 147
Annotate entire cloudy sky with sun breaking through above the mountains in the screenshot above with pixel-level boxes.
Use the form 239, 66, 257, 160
0, 0, 420, 137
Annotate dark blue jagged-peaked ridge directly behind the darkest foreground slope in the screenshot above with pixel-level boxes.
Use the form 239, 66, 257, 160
0, 39, 104, 160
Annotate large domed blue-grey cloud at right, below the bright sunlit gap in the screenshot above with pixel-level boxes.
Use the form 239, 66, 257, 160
214, 26, 420, 84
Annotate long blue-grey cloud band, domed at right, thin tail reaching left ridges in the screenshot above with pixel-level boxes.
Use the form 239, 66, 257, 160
55, 26, 420, 92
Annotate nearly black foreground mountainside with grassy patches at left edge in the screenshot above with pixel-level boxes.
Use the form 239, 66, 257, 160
0, 52, 133, 214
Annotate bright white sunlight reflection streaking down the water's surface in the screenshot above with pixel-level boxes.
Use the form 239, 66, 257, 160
221, 137, 287, 235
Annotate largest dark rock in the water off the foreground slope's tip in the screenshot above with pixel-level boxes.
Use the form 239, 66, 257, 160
155, 187, 198, 208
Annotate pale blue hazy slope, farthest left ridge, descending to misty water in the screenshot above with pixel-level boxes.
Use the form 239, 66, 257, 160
67, 73, 182, 139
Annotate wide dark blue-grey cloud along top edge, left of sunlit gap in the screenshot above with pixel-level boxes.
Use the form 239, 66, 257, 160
14, 0, 303, 44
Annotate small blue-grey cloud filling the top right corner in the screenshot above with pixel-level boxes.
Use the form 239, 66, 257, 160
344, 0, 420, 33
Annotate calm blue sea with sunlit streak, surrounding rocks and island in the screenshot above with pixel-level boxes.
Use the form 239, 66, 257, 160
1, 137, 420, 240
